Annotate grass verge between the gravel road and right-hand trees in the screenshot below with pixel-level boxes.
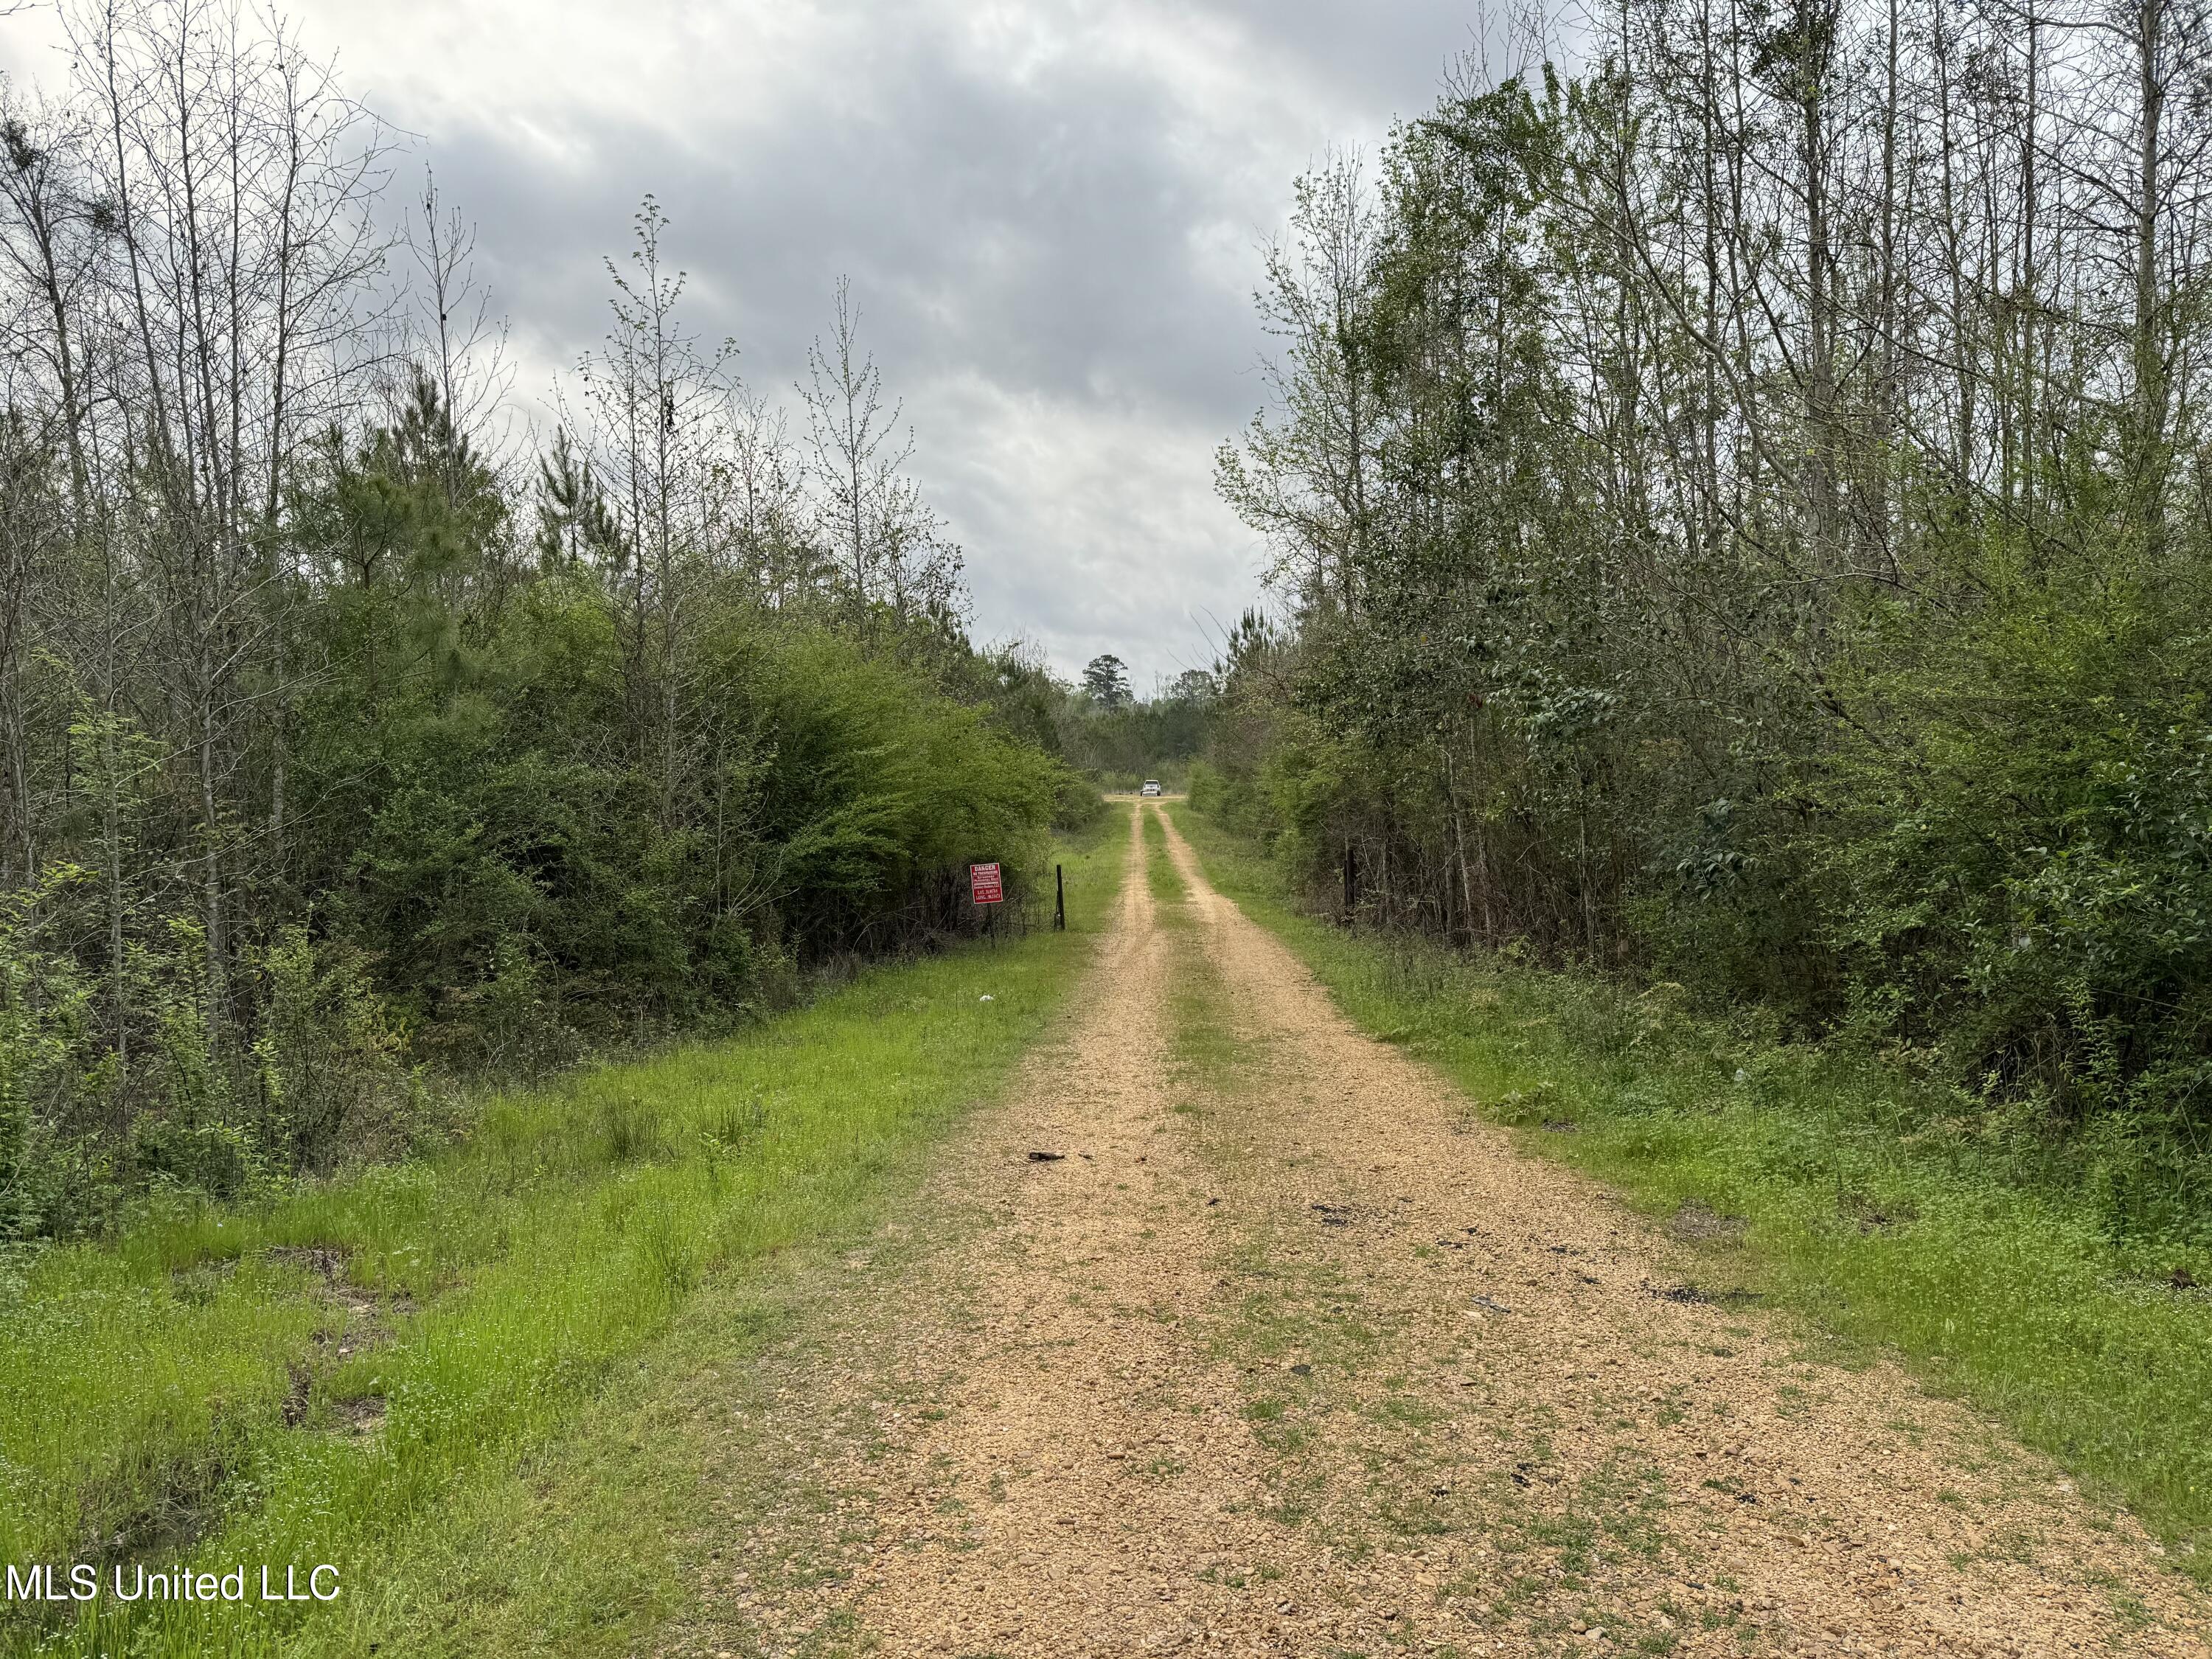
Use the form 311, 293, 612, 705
1175, 807, 2212, 1579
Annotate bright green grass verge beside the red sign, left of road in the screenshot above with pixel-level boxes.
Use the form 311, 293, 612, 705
0, 814, 1126, 1655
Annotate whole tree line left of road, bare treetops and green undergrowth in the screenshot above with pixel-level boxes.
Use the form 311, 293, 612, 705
0, 0, 1082, 1243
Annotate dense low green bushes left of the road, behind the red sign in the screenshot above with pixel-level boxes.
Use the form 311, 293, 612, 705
0, 580, 1066, 1239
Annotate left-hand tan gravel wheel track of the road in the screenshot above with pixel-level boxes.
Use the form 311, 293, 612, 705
836, 801, 1327, 1655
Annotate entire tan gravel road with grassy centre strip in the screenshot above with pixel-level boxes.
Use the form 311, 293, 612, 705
690, 805, 2208, 1655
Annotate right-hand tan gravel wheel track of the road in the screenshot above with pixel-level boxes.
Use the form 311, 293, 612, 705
1168, 801, 2205, 1655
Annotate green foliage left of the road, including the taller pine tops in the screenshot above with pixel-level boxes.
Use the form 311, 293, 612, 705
0, 354, 1071, 1239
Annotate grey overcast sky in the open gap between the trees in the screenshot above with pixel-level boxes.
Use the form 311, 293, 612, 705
0, 0, 1480, 690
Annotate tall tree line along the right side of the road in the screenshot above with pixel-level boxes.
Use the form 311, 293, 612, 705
1197, 0, 2212, 1146
